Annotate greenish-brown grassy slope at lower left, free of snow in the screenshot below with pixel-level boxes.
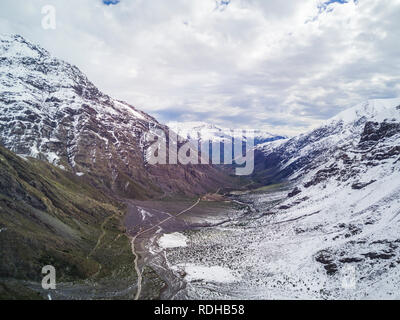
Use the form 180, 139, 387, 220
0, 146, 146, 299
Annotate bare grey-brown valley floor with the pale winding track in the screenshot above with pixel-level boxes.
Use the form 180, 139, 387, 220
125, 198, 244, 299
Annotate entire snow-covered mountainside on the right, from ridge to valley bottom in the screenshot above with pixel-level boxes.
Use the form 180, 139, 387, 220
158, 99, 400, 299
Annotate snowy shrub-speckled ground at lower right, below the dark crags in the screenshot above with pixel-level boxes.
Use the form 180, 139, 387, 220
152, 175, 400, 299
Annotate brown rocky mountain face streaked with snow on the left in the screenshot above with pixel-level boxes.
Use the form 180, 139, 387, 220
0, 36, 231, 198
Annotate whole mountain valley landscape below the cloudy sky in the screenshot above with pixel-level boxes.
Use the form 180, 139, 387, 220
0, 35, 400, 300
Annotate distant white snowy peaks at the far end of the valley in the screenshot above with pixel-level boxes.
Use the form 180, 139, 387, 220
167, 121, 286, 145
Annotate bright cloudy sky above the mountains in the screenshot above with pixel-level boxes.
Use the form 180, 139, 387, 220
0, 0, 400, 135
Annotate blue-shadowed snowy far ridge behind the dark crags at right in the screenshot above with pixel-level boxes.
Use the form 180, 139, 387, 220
255, 99, 400, 183
